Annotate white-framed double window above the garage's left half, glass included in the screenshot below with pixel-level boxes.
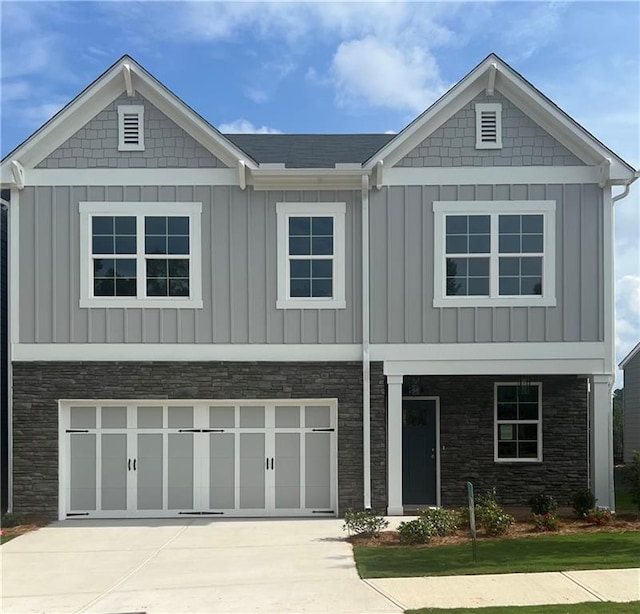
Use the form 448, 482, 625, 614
80, 202, 202, 308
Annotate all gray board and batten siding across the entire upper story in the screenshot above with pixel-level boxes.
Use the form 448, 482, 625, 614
19, 185, 604, 344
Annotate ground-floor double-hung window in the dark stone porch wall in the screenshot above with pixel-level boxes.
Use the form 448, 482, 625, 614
494, 383, 542, 461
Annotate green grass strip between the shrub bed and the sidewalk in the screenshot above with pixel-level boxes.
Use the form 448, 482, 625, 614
353, 531, 640, 578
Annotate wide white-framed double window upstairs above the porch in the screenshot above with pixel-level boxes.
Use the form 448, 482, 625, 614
433, 201, 556, 307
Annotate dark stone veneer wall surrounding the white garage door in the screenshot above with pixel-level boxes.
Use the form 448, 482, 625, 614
13, 362, 387, 517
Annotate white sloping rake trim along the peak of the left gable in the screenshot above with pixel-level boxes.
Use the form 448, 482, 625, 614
2, 56, 256, 177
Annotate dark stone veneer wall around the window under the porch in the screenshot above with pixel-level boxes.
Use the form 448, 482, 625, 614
404, 375, 588, 507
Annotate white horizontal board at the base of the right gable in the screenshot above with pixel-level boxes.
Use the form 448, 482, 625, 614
382, 166, 600, 186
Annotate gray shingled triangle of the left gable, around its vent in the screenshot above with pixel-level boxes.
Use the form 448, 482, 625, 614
36, 93, 227, 168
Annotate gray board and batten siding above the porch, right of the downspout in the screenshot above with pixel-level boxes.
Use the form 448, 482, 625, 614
370, 184, 604, 343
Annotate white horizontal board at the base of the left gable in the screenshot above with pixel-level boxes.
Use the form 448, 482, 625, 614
28, 168, 239, 186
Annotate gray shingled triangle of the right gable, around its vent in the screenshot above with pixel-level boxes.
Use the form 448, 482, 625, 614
395, 92, 584, 167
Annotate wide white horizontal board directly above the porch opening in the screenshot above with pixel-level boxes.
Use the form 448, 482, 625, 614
371, 342, 607, 368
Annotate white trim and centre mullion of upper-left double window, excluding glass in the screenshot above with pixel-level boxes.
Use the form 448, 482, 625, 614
79, 202, 203, 309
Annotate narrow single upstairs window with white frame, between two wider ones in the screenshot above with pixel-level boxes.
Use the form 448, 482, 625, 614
276, 203, 346, 309
